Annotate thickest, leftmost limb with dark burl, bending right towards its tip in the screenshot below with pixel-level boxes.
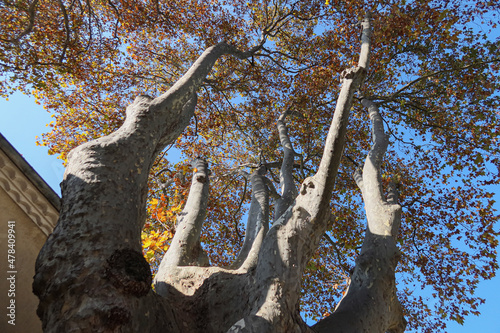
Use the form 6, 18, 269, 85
33, 43, 262, 332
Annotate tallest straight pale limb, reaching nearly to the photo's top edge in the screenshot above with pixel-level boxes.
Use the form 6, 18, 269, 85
228, 13, 370, 332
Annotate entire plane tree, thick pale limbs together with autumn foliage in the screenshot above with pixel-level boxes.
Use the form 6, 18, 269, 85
0, 1, 500, 332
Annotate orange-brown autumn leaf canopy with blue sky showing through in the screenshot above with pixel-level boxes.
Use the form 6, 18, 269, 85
0, 0, 500, 332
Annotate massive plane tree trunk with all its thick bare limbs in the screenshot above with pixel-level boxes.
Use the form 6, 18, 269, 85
33, 13, 404, 333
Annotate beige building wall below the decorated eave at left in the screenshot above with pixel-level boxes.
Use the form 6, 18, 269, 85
0, 187, 46, 333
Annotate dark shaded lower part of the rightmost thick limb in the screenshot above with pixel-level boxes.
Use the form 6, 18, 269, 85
312, 230, 406, 333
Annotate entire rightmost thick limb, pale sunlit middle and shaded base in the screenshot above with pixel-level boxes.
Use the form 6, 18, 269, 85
313, 99, 406, 333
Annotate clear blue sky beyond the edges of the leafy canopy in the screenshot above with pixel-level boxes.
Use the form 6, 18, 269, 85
0, 94, 500, 333
